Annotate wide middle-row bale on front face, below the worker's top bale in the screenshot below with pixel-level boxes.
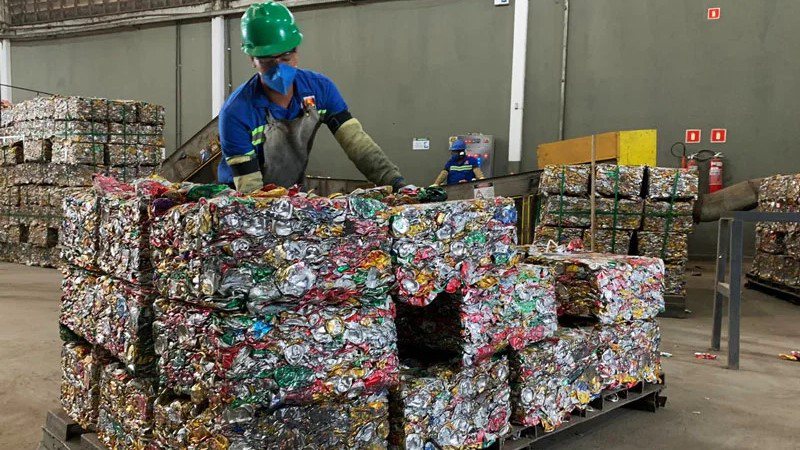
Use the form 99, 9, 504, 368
154, 297, 398, 407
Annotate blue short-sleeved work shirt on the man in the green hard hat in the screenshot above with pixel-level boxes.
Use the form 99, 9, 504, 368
217, 69, 347, 183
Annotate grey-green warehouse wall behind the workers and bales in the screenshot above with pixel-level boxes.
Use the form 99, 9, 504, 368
6, 0, 800, 255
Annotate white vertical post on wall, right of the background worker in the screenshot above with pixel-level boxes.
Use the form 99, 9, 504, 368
508, 0, 528, 173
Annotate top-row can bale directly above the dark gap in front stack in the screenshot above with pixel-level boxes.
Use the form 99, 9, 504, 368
391, 197, 517, 306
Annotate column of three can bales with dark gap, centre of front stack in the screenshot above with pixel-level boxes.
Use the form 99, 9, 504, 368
389, 198, 556, 450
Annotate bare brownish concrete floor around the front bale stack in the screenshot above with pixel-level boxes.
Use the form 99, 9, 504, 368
0, 264, 800, 450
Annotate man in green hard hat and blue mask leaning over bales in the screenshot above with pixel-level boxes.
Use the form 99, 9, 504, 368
217, 1, 405, 193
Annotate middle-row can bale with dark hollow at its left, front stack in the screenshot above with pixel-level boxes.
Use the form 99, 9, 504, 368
397, 264, 557, 366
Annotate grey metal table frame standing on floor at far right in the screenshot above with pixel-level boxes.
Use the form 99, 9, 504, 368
711, 211, 800, 370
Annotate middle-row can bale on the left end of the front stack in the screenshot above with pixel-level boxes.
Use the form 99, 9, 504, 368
60, 268, 155, 374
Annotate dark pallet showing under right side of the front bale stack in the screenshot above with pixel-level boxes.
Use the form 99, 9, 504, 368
491, 375, 667, 450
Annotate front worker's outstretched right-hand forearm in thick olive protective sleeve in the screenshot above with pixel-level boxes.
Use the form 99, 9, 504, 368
334, 118, 403, 186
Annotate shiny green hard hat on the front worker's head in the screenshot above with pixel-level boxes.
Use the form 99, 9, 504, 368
242, 2, 303, 58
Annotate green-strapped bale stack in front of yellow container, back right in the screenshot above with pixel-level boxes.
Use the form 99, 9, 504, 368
534, 164, 697, 295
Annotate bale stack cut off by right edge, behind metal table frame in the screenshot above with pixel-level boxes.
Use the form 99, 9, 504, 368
748, 174, 800, 291
